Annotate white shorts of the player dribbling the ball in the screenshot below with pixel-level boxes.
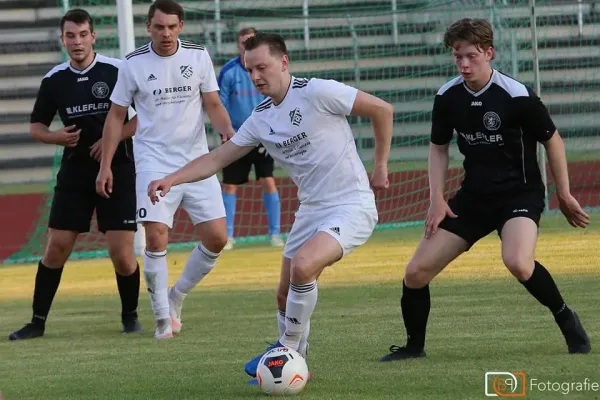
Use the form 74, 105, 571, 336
283, 201, 378, 259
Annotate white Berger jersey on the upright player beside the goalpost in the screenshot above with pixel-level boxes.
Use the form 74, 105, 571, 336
110, 40, 219, 174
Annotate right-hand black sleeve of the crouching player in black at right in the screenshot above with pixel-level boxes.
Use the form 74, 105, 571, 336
515, 88, 556, 142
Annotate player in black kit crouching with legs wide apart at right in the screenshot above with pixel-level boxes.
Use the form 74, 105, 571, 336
381, 19, 591, 361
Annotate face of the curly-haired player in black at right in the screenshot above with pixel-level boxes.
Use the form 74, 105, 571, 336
452, 40, 494, 88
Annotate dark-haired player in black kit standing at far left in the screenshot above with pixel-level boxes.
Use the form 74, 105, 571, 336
9, 9, 141, 340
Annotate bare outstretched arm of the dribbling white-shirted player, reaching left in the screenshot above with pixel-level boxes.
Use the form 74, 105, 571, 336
148, 140, 255, 204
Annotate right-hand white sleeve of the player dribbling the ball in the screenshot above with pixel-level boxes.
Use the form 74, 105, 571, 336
307, 78, 358, 115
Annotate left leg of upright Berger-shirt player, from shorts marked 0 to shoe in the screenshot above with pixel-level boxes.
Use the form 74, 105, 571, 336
136, 172, 183, 339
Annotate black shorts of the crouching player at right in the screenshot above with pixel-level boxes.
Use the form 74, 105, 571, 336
439, 190, 545, 248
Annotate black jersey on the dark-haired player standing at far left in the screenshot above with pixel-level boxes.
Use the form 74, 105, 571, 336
30, 54, 133, 164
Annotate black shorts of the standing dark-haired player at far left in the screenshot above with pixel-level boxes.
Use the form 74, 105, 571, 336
48, 163, 137, 233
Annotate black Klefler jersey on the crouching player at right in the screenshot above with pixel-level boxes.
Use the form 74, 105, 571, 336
431, 70, 556, 195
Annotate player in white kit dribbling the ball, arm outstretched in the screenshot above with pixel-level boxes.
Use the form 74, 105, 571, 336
148, 33, 393, 377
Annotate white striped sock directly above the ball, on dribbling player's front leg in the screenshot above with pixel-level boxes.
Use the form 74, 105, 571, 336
277, 280, 318, 350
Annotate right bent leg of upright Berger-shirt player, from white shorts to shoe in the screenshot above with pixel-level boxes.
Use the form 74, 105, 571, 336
169, 176, 227, 333
